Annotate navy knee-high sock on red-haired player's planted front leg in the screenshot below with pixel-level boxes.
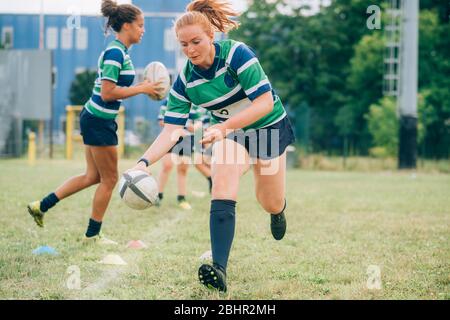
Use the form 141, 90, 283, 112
209, 200, 236, 271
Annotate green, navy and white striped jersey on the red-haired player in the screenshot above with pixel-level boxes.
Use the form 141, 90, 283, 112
164, 39, 286, 130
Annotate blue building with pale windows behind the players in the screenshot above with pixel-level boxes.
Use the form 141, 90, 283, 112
0, 0, 189, 146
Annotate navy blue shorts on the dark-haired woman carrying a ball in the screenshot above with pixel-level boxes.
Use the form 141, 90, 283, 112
80, 108, 118, 147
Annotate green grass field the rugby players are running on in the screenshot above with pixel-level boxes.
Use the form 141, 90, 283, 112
0, 160, 450, 299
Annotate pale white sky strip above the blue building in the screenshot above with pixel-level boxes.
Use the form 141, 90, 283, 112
0, 0, 246, 15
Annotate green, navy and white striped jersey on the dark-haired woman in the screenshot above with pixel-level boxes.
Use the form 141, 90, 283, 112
84, 39, 135, 119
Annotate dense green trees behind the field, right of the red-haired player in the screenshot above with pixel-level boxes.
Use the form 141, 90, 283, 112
231, 0, 450, 157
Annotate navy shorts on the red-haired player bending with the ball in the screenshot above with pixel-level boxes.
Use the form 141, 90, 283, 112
226, 116, 295, 160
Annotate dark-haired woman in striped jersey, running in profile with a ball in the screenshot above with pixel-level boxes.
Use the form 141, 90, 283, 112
28, 0, 161, 244
